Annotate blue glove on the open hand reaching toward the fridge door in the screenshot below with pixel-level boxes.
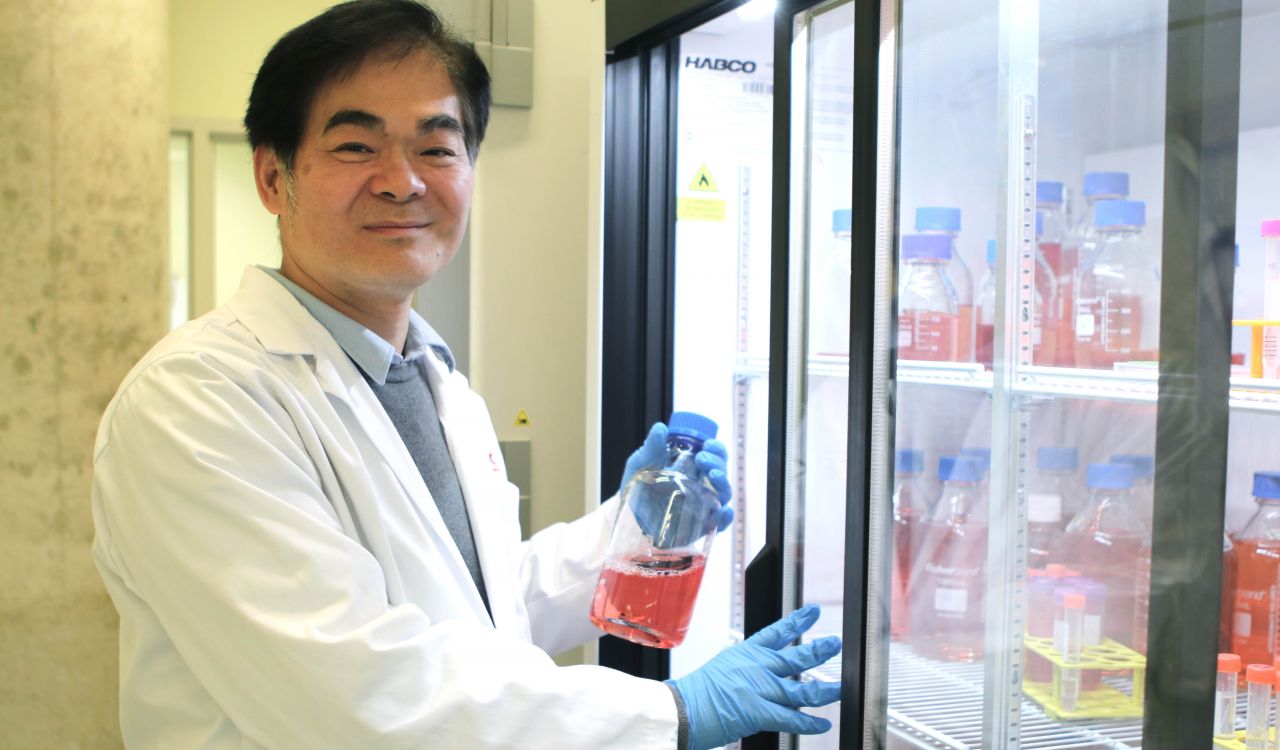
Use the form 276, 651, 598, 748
667, 604, 840, 750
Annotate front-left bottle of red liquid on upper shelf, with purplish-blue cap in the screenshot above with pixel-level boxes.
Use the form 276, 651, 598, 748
897, 234, 960, 362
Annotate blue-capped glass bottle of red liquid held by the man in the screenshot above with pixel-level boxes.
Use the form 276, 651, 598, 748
590, 412, 719, 649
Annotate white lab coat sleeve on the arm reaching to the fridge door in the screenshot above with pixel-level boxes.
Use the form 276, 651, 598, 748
93, 353, 677, 750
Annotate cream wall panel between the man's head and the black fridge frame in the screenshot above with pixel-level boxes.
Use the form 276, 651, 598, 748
468, 0, 604, 537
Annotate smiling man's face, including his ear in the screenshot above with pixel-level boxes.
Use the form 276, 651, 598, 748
253, 52, 475, 307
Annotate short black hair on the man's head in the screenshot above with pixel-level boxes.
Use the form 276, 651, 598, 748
244, 0, 489, 169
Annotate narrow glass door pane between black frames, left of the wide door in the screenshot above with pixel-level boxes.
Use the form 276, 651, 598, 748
782, 0, 854, 747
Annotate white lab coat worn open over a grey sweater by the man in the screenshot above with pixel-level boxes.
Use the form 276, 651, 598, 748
92, 269, 677, 750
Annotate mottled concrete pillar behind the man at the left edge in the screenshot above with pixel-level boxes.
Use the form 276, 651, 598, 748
0, 0, 169, 749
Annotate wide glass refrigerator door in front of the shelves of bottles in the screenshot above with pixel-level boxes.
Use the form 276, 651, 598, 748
846, 0, 1234, 747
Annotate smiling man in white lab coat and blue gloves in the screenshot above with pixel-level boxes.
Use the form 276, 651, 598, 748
93, 0, 838, 749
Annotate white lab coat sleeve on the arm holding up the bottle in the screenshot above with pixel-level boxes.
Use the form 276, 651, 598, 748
520, 497, 620, 654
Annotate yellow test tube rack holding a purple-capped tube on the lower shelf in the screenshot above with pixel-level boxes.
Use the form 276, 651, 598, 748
1023, 636, 1147, 721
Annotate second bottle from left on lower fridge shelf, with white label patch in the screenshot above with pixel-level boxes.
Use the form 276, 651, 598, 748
910, 456, 987, 662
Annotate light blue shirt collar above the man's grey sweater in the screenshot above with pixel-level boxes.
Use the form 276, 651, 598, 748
257, 266, 453, 385
